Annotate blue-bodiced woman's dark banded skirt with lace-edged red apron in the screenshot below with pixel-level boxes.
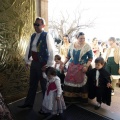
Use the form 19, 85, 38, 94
64, 63, 88, 103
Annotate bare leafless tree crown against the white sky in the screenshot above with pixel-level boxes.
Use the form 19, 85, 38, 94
49, 9, 95, 39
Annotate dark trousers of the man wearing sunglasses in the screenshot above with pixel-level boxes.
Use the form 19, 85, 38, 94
25, 61, 47, 106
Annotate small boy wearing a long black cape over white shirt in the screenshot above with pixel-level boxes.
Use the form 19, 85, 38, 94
86, 57, 111, 110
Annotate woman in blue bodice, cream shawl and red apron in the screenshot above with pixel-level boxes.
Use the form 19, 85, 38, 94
64, 32, 93, 103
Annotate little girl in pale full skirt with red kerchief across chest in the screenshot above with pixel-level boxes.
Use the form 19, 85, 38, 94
42, 67, 66, 115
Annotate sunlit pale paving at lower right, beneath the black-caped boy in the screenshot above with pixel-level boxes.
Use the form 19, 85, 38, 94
80, 87, 120, 120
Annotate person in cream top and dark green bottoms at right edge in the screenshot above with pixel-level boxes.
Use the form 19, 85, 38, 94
105, 37, 120, 95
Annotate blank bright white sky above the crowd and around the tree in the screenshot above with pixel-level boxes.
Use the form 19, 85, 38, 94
49, 0, 120, 40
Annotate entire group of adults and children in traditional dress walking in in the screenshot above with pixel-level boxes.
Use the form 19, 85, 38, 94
18, 17, 120, 118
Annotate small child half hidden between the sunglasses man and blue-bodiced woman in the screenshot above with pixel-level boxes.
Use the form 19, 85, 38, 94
54, 55, 65, 85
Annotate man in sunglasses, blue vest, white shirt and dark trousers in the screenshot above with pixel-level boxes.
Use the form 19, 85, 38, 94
18, 17, 55, 108
